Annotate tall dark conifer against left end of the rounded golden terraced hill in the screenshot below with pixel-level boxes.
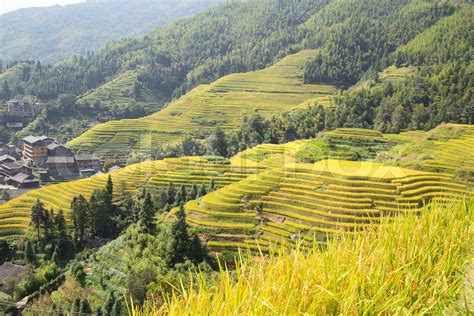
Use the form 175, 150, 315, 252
167, 203, 189, 267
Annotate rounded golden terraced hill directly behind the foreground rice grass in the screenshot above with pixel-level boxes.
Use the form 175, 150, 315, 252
186, 160, 472, 250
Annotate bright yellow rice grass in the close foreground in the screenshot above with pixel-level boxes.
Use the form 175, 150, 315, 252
133, 200, 474, 315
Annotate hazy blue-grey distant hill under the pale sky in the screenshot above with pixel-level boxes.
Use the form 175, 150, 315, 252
0, 0, 222, 63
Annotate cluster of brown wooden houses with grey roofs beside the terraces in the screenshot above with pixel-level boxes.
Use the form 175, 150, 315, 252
0, 136, 103, 189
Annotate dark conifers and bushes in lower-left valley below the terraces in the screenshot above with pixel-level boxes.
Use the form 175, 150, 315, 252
17, 177, 216, 315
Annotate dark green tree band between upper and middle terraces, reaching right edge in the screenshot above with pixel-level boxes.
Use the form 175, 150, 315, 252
195, 63, 474, 157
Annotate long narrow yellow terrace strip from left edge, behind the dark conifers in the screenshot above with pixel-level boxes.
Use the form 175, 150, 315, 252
0, 141, 305, 237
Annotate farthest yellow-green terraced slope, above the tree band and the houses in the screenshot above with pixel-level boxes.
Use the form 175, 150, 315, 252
69, 50, 336, 158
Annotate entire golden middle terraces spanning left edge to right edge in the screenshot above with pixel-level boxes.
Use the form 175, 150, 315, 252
0, 124, 474, 251
